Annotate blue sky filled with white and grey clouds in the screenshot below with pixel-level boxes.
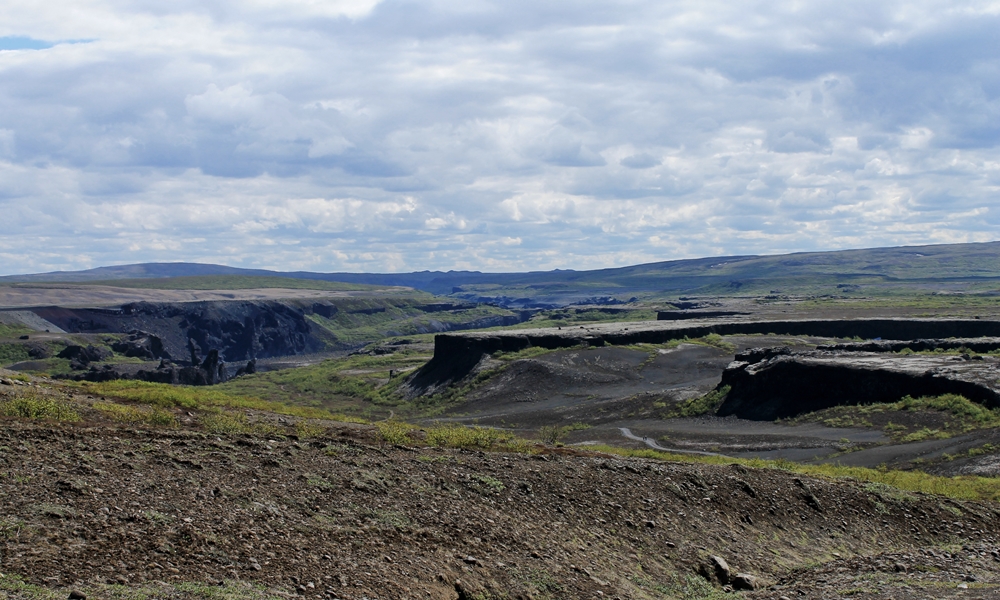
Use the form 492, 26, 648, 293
0, 0, 1000, 274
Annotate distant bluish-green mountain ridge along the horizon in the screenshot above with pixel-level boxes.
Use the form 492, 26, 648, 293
0, 242, 1000, 306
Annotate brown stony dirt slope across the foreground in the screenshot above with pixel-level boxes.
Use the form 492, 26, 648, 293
0, 419, 1000, 600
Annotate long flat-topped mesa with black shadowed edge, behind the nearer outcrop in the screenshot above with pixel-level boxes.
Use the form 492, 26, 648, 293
410, 318, 1000, 395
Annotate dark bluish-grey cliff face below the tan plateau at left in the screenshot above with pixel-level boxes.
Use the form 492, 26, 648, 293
34, 301, 323, 362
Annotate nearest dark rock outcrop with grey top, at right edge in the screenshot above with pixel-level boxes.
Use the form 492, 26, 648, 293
717, 348, 1000, 421
